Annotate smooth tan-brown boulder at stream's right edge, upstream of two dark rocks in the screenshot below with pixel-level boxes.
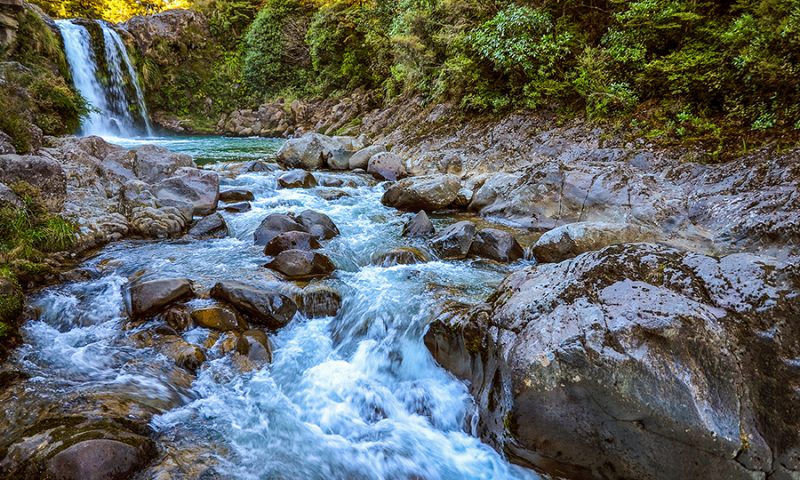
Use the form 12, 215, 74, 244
381, 175, 461, 211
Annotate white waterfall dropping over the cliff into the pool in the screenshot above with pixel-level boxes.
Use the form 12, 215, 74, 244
56, 20, 152, 137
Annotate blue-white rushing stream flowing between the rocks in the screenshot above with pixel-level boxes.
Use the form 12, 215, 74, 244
9, 138, 533, 480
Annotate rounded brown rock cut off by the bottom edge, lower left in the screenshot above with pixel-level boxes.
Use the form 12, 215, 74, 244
45, 438, 153, 480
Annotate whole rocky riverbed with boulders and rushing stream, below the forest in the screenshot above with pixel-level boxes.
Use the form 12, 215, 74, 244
0, 120, 800, 479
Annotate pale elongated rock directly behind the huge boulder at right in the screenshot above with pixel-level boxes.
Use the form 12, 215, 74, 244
533, 222, 655, 262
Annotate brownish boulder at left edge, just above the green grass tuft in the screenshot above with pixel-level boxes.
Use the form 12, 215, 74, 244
0, 155, 67, 213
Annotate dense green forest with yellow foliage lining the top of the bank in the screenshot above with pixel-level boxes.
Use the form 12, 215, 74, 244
9, 0, 800, 159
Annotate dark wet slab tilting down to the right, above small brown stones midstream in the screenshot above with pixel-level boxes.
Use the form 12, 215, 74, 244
211, 281, 297, 329
